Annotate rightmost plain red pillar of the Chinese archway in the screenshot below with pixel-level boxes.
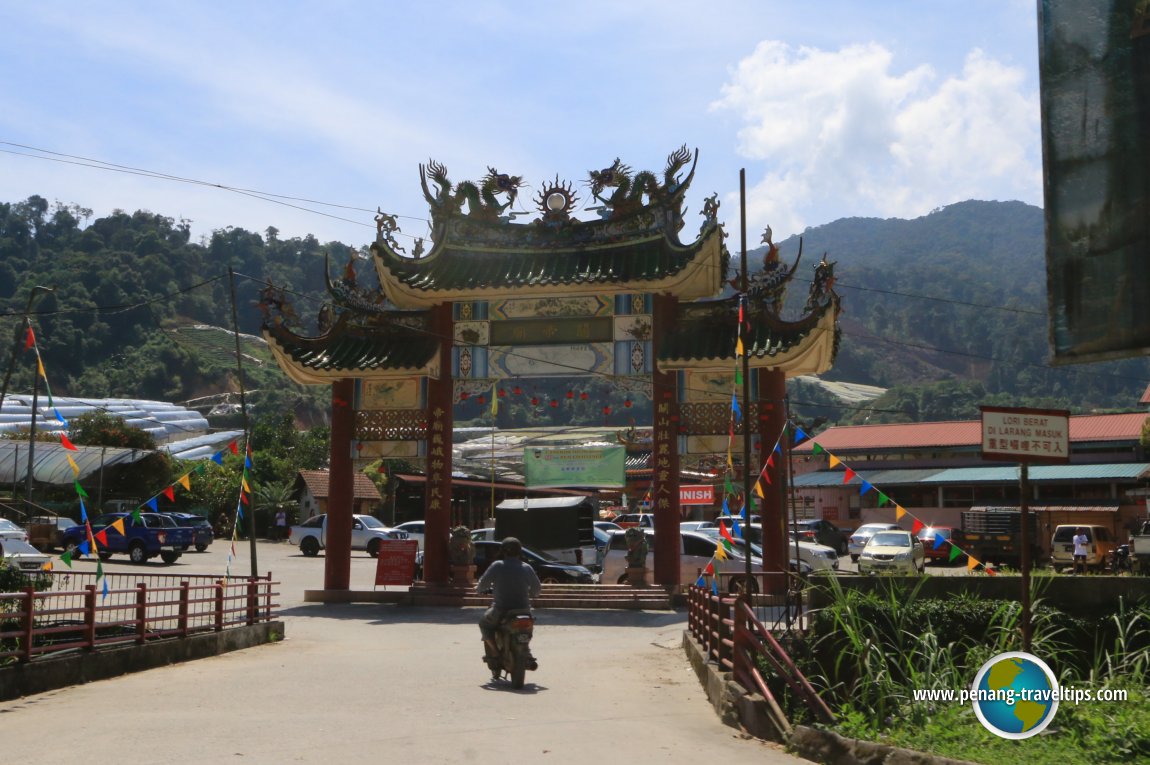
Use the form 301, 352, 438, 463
758, 369, 790, 592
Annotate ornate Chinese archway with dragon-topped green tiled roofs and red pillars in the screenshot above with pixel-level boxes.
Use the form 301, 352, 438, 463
261, 147, 840, 590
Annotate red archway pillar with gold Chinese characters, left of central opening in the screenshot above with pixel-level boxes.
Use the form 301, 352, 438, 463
423, 303, 454, 584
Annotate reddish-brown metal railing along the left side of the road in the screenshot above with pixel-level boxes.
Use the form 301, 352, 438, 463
0, 573, 279, 664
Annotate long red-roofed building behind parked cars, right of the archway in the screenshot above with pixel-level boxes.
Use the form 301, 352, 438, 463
790, 412, 1150, 546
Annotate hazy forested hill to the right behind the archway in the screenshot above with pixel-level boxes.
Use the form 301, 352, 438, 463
772, 196, 1150, 422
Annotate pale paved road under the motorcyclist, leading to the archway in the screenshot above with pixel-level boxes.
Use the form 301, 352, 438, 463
0, 543, 805, 765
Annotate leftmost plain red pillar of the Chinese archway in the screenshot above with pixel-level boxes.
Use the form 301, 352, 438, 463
323, 378, 355, 590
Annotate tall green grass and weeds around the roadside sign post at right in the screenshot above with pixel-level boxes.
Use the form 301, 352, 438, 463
788, 577, 1150, 765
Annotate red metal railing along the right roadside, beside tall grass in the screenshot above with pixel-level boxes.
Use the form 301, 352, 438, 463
687, 584, 835, 736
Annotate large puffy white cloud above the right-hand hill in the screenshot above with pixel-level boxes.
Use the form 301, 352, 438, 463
711, 40, 1042, 235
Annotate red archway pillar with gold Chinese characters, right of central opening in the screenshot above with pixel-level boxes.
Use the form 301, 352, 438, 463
651, 294, 680, 587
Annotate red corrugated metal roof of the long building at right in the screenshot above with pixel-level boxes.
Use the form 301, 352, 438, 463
795, 412, 1147, 452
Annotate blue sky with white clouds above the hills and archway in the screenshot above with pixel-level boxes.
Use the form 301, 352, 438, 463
0, 0, 1042, 250
